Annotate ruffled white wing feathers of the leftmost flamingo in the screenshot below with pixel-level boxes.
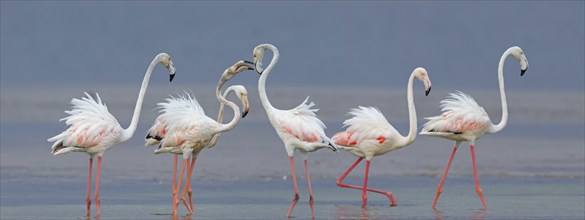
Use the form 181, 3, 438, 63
47, 92, 123, 153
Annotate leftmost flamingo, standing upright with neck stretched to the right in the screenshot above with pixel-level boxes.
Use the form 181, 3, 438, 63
47, 53, 175, 216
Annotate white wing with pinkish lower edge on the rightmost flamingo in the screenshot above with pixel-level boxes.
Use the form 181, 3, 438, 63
421, 91, 491, 135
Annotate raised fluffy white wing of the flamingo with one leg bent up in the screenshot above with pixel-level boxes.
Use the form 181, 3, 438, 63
332, 106, 397, 147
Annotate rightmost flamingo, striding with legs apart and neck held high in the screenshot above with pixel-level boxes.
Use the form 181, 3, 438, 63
420, 46, 528, 209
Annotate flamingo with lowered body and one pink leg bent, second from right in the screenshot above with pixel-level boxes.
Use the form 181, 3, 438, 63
332, 67, 431, 207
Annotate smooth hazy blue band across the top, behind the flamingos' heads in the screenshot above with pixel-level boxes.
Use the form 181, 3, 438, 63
0, 1, 585, 91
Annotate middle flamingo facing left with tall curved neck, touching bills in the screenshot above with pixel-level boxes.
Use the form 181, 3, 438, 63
253, 44, 337, 217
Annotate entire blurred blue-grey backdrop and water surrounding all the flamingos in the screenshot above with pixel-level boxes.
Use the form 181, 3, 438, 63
0, 1, 585, 219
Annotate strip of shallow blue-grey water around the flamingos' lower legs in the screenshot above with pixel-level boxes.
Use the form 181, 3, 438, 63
1, 177, 585, 219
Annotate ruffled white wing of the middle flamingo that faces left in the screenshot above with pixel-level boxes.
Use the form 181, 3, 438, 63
278, 97, 334, 146
